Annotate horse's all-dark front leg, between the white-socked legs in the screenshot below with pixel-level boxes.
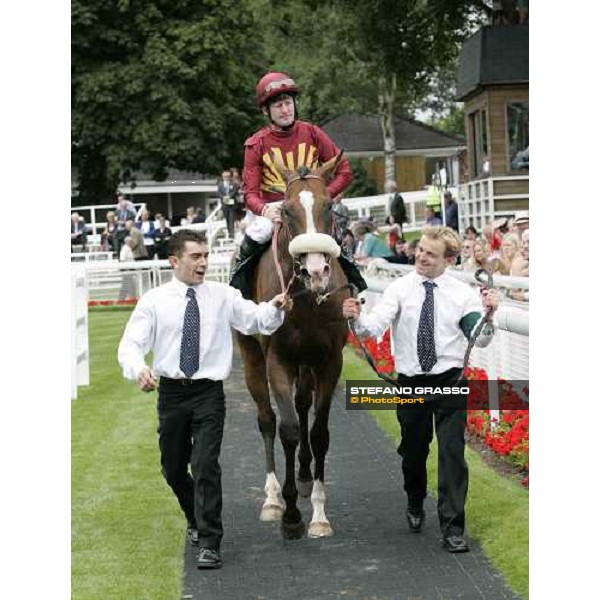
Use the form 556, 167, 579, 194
267, 352, 305, 539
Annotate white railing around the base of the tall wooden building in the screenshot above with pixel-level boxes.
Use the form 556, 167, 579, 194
458, 175, 529, 231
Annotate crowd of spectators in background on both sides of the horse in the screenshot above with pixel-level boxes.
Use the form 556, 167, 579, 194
71, 185, 529, 296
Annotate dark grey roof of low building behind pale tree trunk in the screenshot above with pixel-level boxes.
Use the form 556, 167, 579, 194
321, 113, 465, 154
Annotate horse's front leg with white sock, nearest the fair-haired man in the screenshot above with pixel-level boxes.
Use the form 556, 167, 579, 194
308, 356, 342, 537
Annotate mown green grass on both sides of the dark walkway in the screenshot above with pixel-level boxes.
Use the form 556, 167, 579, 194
71, 308, 529, 600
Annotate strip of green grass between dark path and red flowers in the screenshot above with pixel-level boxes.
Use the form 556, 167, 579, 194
341, 348, 529, 597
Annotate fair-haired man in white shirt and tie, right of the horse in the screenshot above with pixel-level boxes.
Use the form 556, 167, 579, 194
343, 226, 500, 553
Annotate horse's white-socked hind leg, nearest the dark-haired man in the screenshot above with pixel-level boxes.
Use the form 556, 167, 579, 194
238, 334, 283, 521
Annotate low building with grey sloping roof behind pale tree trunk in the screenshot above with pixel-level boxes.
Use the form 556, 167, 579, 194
321, 113, 466, 194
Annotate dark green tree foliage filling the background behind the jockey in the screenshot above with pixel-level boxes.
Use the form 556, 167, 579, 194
72, 0, 481, 201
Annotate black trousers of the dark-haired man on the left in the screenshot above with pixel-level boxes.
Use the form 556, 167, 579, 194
158, 377, 225, 550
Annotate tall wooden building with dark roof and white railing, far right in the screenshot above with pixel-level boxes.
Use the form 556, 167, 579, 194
457, 24, 529, 229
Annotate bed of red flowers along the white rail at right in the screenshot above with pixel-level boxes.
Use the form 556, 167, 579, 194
348, 329, 529, 488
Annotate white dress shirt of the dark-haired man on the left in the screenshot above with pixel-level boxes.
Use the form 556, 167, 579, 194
118, 277, 285, 381
